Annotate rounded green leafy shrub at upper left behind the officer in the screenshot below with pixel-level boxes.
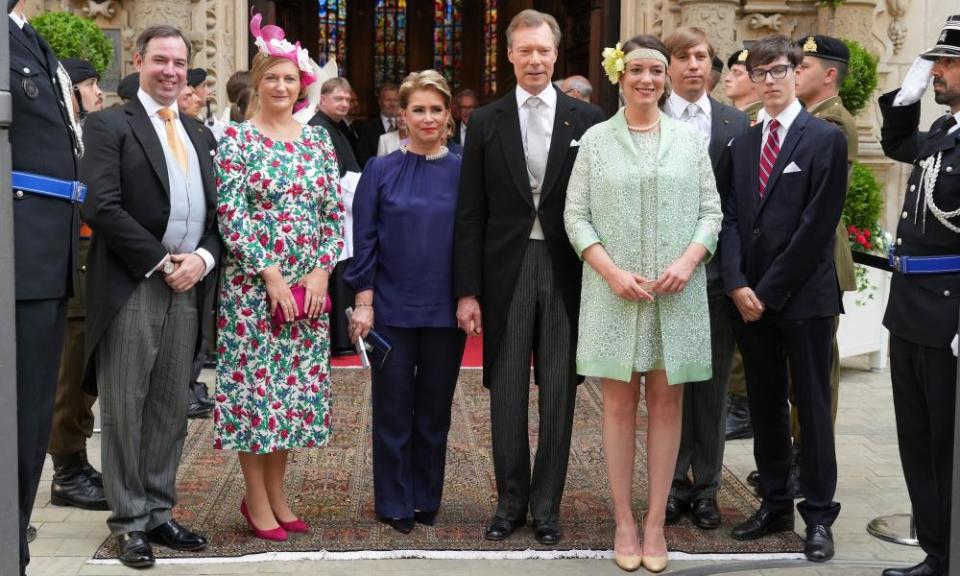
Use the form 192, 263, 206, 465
30, 12, 113, 74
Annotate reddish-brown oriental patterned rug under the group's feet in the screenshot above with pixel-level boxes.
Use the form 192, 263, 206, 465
94, 368, 803, 560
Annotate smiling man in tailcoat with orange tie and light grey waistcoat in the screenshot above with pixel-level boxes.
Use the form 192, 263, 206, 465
81, 25, 220, 568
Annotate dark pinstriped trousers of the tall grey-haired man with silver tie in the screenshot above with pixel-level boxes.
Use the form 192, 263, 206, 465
489, 240, 577, 522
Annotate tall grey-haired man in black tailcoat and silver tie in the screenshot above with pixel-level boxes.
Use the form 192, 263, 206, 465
454, 10, 603, 545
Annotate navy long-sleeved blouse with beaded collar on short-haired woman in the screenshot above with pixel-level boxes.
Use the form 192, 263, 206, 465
344, 150, 460, 328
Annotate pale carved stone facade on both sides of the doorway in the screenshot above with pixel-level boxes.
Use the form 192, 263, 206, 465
28, 0, 948, 230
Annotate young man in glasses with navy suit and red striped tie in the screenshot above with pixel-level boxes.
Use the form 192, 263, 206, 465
720, 36, 847, 562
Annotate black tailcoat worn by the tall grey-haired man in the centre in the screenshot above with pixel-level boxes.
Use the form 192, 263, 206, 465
454, 90, 604, 386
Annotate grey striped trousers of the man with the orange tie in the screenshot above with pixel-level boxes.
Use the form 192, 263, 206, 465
95, 274, 199, 535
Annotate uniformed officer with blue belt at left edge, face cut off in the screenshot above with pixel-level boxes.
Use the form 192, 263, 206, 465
7, 0, 83, 574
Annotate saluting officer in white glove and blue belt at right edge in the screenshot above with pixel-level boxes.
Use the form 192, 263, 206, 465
880, 15, 960, 576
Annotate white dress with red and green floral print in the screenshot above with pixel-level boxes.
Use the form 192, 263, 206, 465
214, 122, 343, 454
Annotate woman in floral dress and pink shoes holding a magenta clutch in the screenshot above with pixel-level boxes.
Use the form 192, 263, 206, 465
214, 36, 343, 540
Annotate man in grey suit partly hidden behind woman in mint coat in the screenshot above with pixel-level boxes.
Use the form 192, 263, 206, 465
663, 26, 750, 529
